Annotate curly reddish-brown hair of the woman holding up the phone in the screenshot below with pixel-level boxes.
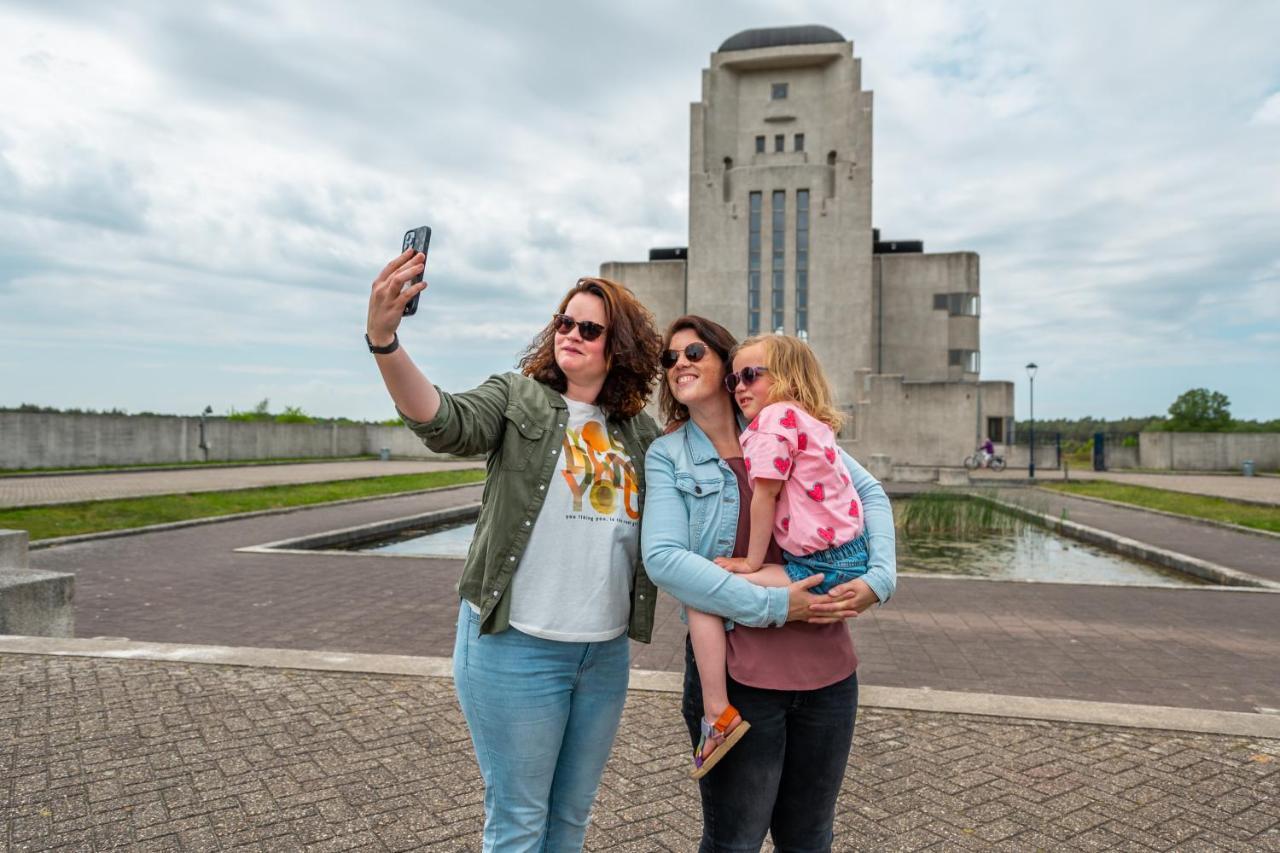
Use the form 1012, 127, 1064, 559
520, 277, 662, 418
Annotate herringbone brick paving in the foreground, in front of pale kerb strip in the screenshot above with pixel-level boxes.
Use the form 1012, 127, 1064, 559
0, 654, 1280, 853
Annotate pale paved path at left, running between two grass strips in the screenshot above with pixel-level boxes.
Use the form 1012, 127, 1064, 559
0, 460, 483, 507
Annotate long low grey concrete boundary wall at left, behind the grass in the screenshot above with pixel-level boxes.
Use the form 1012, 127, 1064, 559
0, 412, 460, 469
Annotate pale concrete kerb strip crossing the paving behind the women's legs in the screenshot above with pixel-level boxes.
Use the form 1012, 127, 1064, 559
0, 635, 1280, 739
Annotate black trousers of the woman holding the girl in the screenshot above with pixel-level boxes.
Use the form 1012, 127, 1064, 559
682, 639, 858, 853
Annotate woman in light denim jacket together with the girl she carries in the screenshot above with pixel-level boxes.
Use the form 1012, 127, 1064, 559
641, 316, 895, 852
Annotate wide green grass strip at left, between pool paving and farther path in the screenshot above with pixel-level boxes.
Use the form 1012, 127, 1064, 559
0, 469, 484, 542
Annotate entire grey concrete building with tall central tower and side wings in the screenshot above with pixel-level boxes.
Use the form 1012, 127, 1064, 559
600, 27, 1014, 465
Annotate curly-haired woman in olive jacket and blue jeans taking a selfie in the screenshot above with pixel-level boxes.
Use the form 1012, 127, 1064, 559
367, 251, 660, 853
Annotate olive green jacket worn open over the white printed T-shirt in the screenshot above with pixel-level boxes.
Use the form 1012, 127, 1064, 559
401, 373, 659, 643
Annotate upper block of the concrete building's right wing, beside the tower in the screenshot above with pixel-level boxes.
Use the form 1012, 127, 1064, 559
873, 252, 979, 382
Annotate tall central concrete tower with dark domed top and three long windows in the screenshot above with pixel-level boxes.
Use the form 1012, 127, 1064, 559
689, 21, 873, 401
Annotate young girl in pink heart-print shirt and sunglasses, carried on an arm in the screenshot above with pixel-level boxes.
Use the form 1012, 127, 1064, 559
689, 336, 868, 779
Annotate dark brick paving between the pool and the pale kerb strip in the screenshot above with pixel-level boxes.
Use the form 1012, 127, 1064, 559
31, 487, 1280, 712
